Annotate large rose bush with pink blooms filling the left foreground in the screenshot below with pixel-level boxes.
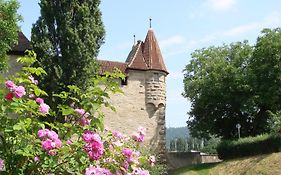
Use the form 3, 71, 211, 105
0, 52, 164, 175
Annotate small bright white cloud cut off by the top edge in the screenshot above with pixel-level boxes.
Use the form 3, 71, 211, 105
206, 0, 237, 11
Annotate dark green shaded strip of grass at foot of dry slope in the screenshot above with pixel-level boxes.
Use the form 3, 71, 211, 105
169, 163, 219, 175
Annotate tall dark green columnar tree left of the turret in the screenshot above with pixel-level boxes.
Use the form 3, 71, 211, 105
31, 0, 105, 119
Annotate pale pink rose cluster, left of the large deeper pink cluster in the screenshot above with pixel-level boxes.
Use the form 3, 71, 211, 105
37, 129, 62, 156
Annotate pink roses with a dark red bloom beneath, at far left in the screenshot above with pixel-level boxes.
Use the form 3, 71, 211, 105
5, 80, 26, 100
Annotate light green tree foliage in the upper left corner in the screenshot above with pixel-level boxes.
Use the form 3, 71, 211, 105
0, 0, 21, 72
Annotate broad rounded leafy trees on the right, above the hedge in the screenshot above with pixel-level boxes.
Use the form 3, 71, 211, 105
183, 28, 281, 139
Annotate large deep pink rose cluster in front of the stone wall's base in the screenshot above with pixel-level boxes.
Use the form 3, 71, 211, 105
82, 131, 104, 160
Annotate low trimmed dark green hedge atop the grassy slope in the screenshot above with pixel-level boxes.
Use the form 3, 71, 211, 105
217, 134, 281, 160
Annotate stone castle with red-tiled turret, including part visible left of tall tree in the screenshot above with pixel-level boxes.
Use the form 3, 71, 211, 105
9, 29, 168, 153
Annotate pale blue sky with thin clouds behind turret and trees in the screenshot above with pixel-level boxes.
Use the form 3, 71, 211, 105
19, 0, 281, 127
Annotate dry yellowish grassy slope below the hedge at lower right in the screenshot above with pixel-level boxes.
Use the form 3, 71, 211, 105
170, 153, 281, 175
